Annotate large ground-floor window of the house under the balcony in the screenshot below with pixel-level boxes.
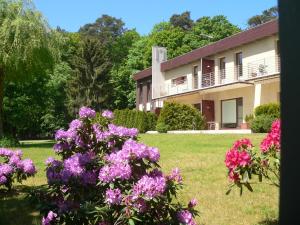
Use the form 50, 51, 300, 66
221, 98, 243, 128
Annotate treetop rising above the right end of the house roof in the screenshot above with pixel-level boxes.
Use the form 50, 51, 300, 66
248, 6, 278, 27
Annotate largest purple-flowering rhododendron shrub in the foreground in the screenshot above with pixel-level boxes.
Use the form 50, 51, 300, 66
42, 107, 197, 225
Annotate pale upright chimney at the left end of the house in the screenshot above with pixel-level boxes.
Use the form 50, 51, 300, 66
152, 46, 167, 99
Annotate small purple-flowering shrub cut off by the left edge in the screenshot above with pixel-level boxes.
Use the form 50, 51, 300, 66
0, 148, 36, 190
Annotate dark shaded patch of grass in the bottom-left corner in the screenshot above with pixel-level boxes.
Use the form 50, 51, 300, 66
0, 186, 41, 225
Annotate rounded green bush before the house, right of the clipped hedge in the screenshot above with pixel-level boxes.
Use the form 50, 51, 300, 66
157, 102, 205, 130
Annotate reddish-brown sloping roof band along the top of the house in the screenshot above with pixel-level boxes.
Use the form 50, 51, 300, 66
134, 20, 278, 80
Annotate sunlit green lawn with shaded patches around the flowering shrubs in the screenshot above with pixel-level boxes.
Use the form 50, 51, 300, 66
0, 134, 278, 225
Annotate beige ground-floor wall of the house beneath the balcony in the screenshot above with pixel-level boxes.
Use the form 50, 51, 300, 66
167, 78, 280, 127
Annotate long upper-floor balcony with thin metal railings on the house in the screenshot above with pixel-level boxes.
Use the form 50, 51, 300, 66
160, 56, 280, 97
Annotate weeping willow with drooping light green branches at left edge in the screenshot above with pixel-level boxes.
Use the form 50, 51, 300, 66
0, 0, 54, 136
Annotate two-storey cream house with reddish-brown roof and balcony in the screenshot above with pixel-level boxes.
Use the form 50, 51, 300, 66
134, 20, 280, 129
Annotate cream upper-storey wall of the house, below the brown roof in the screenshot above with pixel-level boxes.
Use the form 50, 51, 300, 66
159, 35, 278, 95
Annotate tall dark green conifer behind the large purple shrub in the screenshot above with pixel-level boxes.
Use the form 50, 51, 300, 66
68, 37, 112, 115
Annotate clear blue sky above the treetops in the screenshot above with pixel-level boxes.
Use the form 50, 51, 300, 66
34, 0, 277, 34
